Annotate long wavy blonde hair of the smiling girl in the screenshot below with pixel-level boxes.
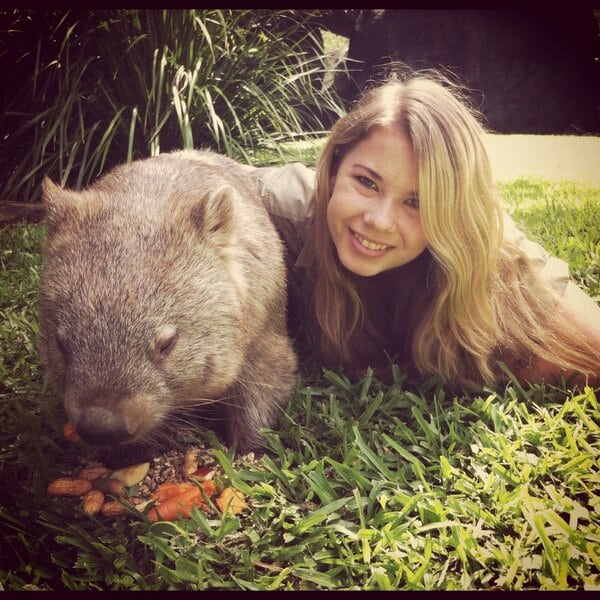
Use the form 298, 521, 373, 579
312, 72, 600, 387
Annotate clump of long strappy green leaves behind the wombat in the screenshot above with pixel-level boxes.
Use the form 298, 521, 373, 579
0, 9, 342, 200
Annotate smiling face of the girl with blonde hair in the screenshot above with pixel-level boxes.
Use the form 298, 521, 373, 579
327, 127, 427, 277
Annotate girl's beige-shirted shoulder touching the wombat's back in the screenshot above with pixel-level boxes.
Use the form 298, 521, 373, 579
253, 163, 315, 223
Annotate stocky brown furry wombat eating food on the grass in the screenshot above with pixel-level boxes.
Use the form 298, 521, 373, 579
39, 150, 296, 460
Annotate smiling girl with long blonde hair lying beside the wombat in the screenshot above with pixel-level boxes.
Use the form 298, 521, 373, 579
246, 74, 600, 388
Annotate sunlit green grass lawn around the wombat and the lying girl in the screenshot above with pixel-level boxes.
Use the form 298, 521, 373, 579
0, 180, 600, 590
